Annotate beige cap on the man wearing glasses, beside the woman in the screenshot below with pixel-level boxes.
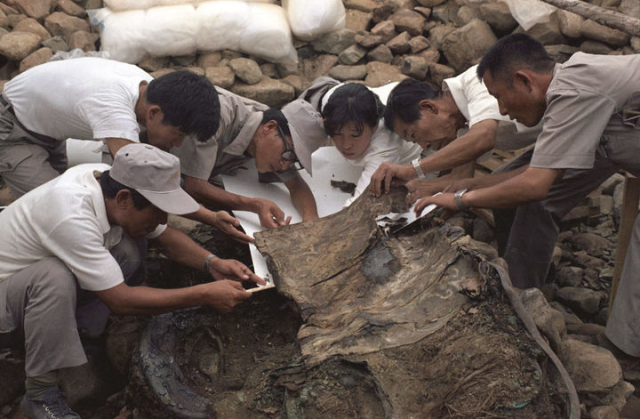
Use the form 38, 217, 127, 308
282, 99, 327, 174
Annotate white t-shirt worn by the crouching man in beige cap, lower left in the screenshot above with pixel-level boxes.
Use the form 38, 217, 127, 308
0, 164, 166, 291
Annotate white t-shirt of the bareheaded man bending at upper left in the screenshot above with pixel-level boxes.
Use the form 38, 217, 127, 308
3, 57, 153, 142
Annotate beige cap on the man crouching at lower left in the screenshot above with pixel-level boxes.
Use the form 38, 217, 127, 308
109, 144, 200, 215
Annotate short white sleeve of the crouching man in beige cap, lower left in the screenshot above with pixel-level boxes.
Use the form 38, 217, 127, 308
43, 216, 124, 291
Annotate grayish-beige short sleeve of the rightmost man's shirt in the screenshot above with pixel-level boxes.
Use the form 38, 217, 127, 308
531, 89, 615, 169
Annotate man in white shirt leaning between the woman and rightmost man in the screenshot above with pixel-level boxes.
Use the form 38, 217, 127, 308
371, 66, 539, 202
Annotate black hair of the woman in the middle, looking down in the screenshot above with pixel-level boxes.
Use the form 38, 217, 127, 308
322, 83, 384, 137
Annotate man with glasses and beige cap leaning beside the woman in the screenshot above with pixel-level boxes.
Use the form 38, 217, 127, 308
171, 87, 326, 228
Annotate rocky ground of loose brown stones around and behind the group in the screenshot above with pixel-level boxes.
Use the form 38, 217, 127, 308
0, 0, 640, 418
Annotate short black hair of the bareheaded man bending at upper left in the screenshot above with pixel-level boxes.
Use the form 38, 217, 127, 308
145, 70, 220, 142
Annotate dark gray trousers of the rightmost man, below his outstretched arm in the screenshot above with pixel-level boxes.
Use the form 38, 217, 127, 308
493, 149, 618, 289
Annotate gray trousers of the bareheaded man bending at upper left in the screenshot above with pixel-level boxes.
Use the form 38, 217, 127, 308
0, 106, 67, 198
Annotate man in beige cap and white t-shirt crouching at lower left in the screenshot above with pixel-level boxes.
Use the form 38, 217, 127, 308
0, 144, 264, 418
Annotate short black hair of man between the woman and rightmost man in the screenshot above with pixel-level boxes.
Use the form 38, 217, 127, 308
384, 78, 442, 131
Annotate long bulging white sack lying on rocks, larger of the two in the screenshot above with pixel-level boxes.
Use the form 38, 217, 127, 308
91, 1, 297, 64
